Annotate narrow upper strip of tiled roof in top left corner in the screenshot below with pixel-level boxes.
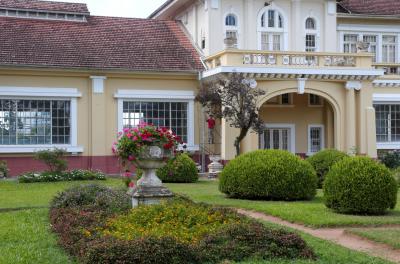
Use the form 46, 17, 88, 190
0, 0, 89, 13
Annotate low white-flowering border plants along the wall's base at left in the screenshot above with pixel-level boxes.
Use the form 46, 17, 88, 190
18, 170, 106, 183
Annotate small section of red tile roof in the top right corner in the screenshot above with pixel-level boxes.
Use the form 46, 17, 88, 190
338, 0, 400, 16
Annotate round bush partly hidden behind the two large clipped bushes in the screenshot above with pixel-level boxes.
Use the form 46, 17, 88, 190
307, 149, 348, 188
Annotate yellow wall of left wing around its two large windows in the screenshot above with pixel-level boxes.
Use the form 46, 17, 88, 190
0, 70, 200, 156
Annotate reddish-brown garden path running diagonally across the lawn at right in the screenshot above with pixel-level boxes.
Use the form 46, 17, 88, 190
237, 209, 400, 263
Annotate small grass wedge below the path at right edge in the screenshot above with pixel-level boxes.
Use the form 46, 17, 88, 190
347, 227, 400, 249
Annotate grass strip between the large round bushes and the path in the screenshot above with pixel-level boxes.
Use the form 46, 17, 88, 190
168, 181, 400, 227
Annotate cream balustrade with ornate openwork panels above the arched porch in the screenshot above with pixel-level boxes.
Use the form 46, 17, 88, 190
205, 49, 373, 69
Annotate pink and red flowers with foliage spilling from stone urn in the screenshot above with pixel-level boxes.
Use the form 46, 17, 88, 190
112, 123, 180, 164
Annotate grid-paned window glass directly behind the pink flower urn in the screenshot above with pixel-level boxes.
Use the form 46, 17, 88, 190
123, 101, 188, 142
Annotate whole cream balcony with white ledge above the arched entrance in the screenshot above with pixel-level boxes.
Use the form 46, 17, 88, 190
203, 49, 384, 80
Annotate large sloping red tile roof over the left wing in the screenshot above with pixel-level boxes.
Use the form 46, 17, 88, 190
0, 16, 203, 71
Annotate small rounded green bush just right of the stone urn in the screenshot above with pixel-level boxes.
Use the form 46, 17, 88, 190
157, 154, 199, 183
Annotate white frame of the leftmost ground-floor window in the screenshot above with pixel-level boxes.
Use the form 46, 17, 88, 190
0, 86, 83, 153
